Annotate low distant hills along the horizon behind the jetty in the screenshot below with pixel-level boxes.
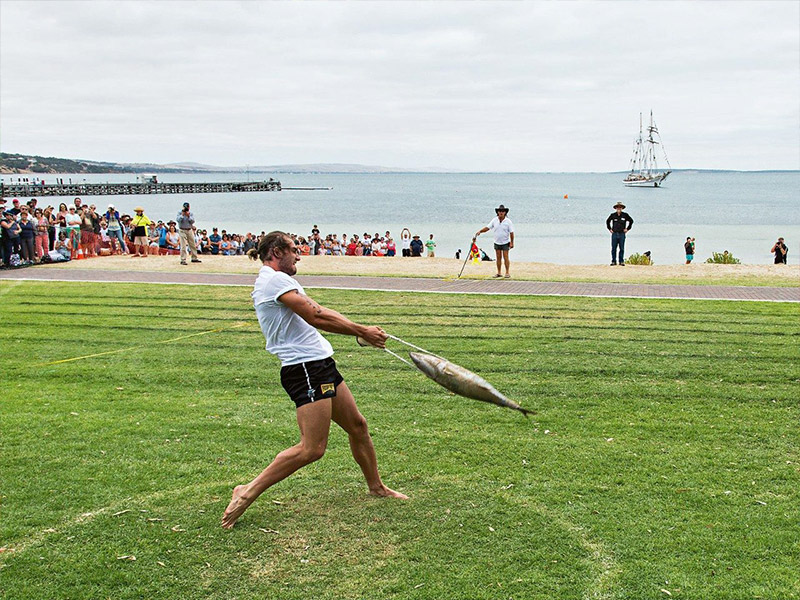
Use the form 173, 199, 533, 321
0, 152, 460, 174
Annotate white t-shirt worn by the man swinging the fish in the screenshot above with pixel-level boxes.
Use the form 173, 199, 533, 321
251, 266, 333, 367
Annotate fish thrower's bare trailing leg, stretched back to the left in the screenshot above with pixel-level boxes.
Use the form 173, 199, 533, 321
222, 398, 331, 529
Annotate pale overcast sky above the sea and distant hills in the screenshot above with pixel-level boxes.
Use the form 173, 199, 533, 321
0, 0, 800, 171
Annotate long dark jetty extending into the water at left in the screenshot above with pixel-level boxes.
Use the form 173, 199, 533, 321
0, 179, 282, 198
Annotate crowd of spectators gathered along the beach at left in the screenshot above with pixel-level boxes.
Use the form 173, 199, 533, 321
0, 198, 436, 267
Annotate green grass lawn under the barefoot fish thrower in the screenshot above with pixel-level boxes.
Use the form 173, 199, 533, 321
0, 281, 800, 600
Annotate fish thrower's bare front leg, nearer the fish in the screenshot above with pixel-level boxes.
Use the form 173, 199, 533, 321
332, 381, 408, 500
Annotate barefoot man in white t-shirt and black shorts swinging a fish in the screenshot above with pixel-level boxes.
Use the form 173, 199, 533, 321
222, 231, 408, 529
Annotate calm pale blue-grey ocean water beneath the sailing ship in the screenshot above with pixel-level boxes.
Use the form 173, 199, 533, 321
3, 171, 800, 265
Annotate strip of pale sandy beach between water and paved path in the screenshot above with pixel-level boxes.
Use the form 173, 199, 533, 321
39, 255, 800, 287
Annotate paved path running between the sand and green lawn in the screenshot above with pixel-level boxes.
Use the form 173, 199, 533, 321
0, 267, 800, 302
